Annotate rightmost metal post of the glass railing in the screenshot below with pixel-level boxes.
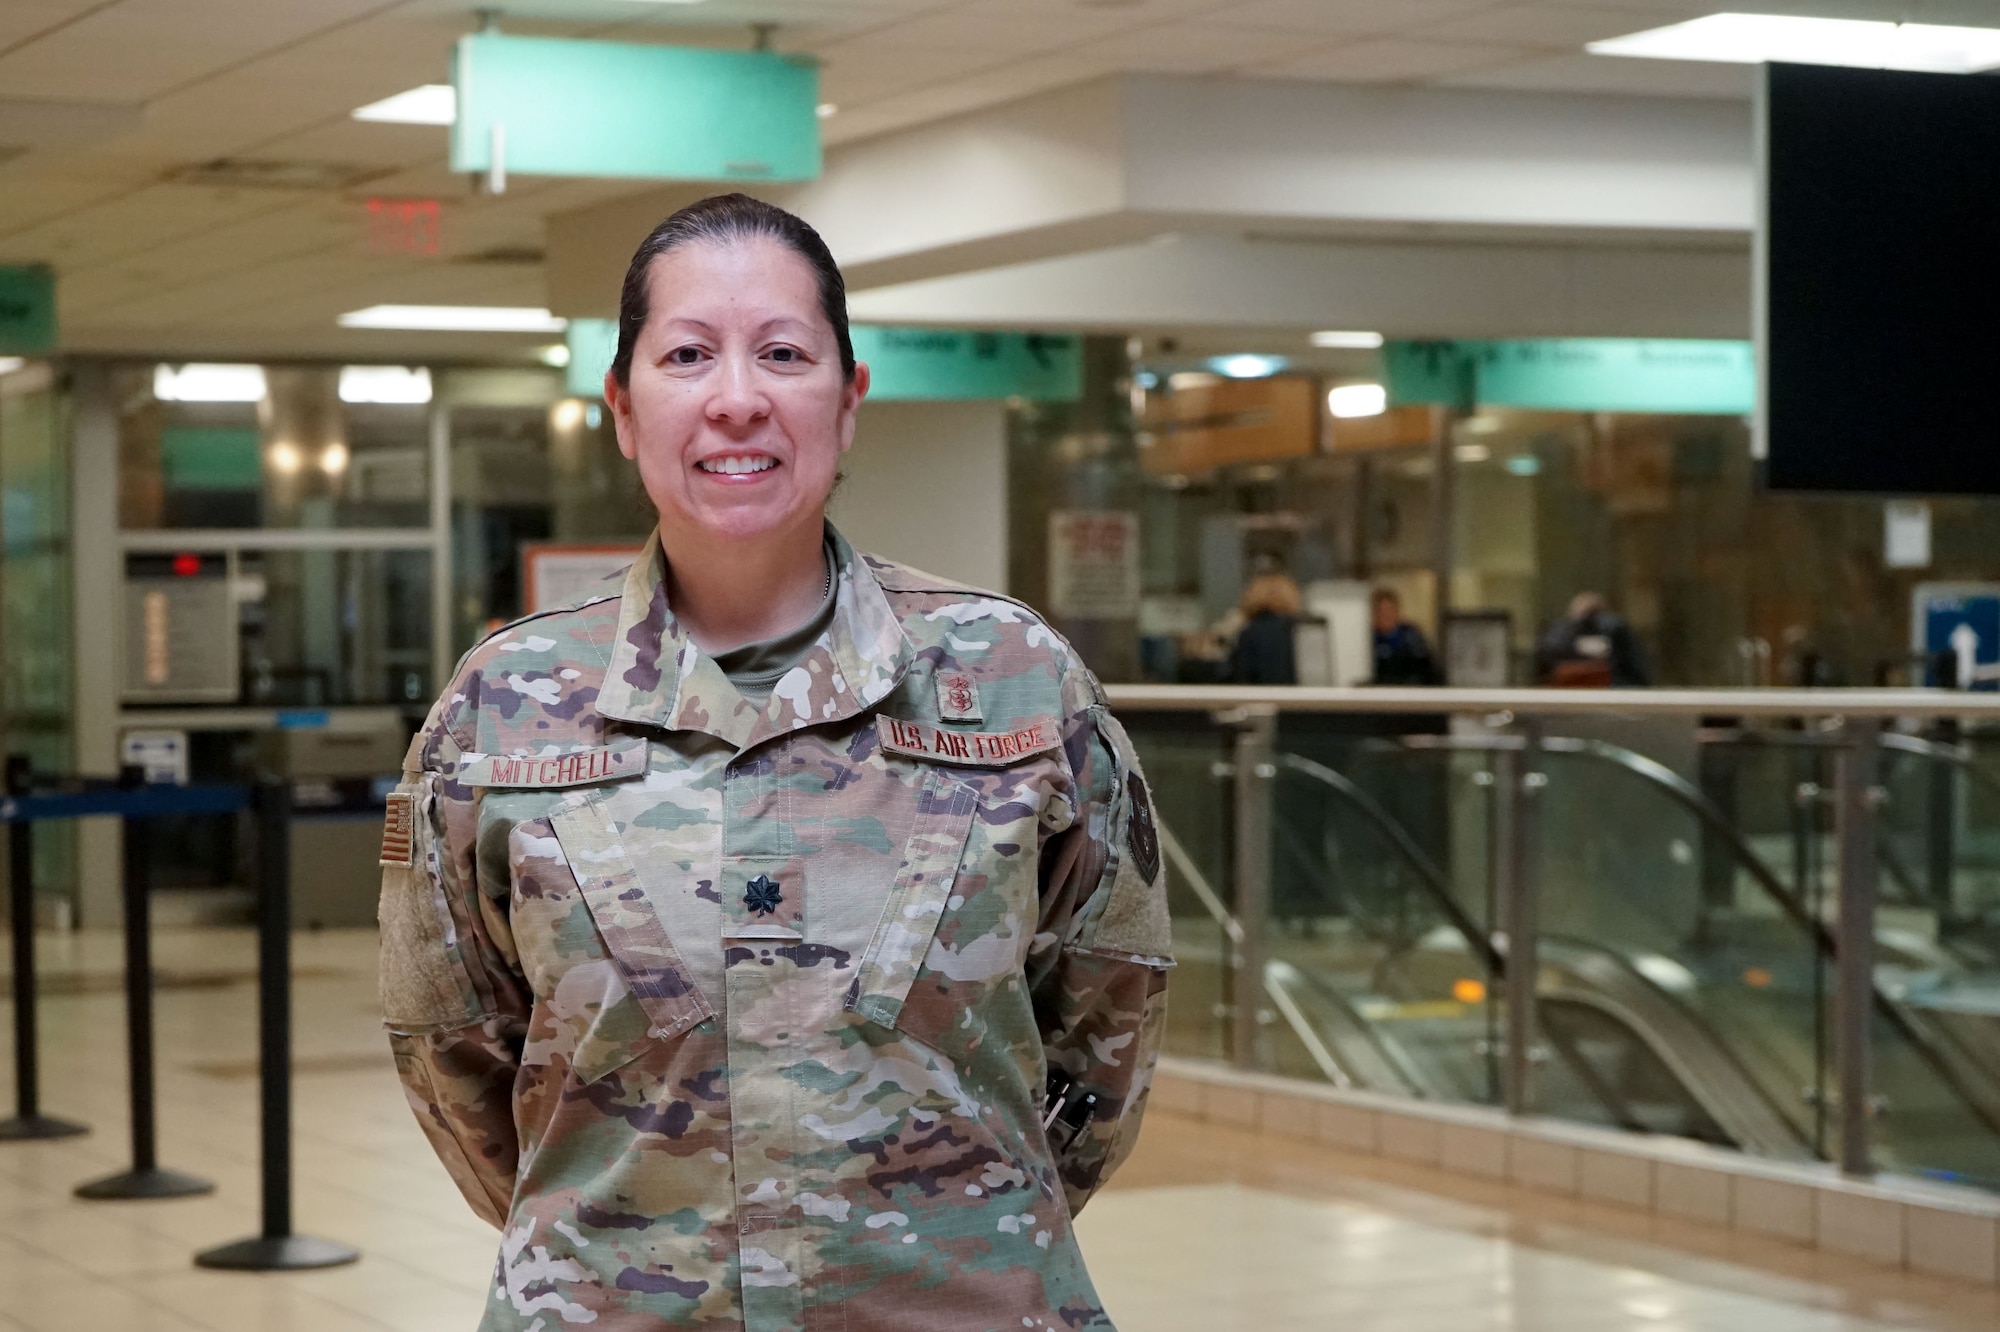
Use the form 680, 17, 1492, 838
1834, 718, 1882, 1176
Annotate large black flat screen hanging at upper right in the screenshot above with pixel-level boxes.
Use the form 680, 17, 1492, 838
1758, 64, 2000, 494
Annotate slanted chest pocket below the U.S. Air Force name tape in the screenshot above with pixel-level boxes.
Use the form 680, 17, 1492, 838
846, 768, 1036, 1048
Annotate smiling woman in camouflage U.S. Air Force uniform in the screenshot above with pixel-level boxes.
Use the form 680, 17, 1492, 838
382, 196, 1170, 1332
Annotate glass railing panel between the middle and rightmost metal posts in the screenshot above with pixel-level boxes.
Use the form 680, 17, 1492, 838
1536, 736, 1832, 1158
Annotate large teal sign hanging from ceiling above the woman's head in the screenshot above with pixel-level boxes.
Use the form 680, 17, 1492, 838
452, 32, 820, 180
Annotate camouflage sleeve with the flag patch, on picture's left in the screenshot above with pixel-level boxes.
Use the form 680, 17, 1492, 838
380, 704, 528, 1226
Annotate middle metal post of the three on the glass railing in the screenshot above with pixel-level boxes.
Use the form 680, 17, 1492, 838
1494, 722, 1548, 1114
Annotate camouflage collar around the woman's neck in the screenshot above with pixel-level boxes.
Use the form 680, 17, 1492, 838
598, 524, 916, 750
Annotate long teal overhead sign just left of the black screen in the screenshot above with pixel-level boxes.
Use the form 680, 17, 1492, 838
1382, 338, 1756, 416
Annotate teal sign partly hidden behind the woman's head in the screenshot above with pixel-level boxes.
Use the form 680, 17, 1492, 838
564, 320, 1084, 402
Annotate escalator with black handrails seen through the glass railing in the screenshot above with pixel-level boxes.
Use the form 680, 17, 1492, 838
1170, 736, 2000, 1182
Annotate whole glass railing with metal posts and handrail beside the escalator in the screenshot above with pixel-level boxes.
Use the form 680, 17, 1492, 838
1112, 686, 2000, 1188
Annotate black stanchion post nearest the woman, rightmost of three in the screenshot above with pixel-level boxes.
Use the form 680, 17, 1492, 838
194, 780, 360, 1272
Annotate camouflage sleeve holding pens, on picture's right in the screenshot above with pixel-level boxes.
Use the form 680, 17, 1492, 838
1030, 684, 1174, 1214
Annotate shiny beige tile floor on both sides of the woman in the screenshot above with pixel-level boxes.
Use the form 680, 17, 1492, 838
0, 930, 2000, 1332
